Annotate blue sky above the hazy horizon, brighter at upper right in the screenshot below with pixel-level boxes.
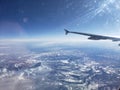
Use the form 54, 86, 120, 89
0, 0, 120, 38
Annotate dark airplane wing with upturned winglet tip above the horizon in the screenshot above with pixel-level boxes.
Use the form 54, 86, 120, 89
64, 29, 120, 43
